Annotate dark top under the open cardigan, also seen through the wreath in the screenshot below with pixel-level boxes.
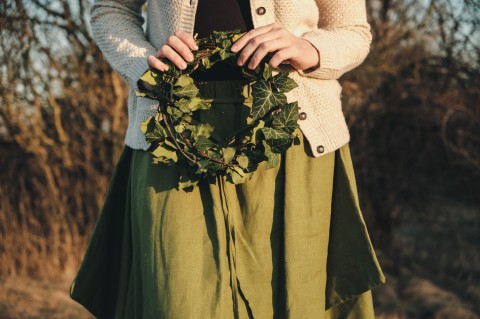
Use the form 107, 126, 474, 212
191, 0, 253, 81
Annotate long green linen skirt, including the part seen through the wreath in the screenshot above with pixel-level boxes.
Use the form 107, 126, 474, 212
70, 80, 385, 319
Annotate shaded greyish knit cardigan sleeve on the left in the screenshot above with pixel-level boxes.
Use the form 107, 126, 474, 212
90, 0, 157, 89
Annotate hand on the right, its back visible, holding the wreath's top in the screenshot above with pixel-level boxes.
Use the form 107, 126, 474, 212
232, 23, 320, 70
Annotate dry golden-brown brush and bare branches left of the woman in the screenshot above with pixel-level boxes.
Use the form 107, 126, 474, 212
0, 1, 128, 277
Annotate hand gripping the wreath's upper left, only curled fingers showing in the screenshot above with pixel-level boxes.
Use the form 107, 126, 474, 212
147, 30, 198, 71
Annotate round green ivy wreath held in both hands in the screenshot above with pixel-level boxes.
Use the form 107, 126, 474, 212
136, 29, 299, 191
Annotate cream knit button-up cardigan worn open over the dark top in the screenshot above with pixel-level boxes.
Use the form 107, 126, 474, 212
90, 0, 371, 157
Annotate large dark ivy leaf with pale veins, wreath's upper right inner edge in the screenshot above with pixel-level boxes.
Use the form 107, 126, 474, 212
250, 80, 287, 121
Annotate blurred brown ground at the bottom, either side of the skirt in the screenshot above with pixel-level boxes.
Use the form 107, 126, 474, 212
0, 270, 480, 319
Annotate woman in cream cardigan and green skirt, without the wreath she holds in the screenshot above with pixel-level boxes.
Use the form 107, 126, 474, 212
71, 0, 385, 319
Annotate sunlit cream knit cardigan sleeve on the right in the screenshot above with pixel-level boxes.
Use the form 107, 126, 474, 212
298, 0, 372, 80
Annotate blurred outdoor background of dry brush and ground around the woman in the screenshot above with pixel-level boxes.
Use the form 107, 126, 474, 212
0, 0, 480, 319
